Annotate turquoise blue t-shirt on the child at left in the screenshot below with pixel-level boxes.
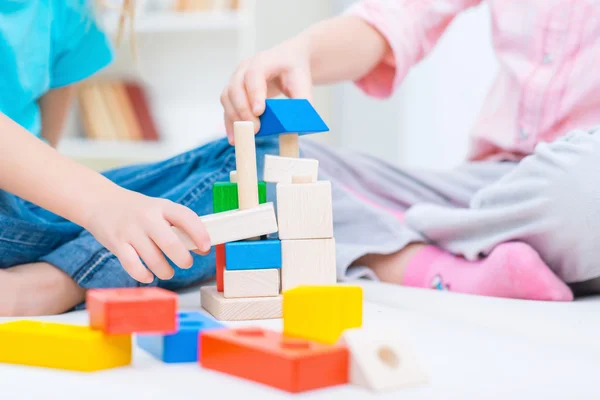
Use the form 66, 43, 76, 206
0, 0, 112, 137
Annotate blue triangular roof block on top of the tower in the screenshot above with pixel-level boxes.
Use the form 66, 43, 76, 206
257, 99, 329, 136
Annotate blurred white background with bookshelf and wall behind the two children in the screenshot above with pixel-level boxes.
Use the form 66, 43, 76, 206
59, 0, 496, 169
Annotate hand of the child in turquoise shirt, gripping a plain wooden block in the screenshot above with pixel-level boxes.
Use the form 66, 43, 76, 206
85, 189, 210, 283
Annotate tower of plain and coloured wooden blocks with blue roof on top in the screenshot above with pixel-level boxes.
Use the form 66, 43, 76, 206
201, 99, 336, 320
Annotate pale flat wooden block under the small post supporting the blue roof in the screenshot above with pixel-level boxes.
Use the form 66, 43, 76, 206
263, 154, 319, 183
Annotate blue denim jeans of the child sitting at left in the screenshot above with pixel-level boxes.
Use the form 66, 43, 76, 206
0, 138, 277, 300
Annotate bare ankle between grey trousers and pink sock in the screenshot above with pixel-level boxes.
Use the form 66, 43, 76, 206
354, 243, 427, 285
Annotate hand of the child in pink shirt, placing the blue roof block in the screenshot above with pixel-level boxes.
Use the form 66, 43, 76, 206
221, 37, 312, 143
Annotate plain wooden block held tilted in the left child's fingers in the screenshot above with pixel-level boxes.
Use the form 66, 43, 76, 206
172, 203, 277, 250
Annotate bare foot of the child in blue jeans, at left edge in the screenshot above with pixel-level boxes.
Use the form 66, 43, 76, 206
0, 263, 85, 317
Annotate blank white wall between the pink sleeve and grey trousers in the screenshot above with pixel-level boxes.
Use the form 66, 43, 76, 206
332, 0, 496, 168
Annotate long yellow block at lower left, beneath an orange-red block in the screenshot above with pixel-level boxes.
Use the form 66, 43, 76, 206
0, 321, 131, 372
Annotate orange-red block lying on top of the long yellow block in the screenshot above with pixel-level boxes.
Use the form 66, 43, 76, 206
87, 287, 177, 335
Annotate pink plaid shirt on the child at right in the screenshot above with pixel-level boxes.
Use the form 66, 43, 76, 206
348, 0, 600, 160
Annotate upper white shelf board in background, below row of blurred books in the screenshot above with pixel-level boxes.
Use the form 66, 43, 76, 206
104, 11, 245, 34
